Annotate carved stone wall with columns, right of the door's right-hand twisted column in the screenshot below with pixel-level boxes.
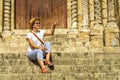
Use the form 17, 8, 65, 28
78, 0, 120, 46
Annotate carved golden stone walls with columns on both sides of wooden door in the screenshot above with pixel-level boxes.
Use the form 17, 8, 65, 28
0, 0, 120, 47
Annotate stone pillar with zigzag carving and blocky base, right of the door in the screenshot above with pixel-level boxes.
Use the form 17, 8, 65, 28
90, 0, 103, 46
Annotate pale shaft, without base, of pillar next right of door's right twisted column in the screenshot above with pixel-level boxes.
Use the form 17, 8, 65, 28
81, 0, 89, 32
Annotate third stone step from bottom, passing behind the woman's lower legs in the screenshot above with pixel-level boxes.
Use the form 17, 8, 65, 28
0, 58, 120, 66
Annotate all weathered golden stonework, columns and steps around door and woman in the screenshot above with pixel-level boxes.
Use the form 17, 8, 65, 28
0, 0, 120, 80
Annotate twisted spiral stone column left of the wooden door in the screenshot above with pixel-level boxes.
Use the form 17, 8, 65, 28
3, 0, 11, 33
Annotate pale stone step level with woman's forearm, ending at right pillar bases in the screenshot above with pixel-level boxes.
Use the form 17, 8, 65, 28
0, 38, 83, 47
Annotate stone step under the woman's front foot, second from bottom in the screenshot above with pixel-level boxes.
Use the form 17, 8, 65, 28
0, 65, 120, 74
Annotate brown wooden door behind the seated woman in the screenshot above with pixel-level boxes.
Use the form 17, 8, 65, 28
15, 0, 67, 29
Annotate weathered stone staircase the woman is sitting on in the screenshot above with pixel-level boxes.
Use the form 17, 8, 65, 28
0, 34, 120, 80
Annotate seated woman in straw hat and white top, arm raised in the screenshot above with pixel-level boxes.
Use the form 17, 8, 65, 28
27, 18, 57, 73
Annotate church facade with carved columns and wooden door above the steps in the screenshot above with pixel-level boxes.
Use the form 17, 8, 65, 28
0, 0, 120, 47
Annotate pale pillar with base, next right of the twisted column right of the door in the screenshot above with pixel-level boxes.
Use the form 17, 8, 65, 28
77, 0, 89, 43
